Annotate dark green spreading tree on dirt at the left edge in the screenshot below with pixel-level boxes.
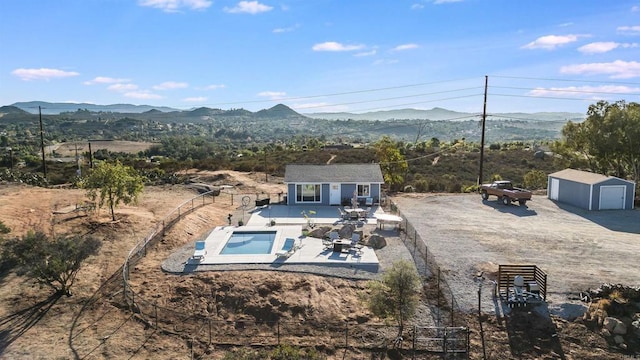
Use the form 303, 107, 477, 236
2, 232, 101, 296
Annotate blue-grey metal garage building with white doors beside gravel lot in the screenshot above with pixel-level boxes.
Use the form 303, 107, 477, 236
547, 169, 636, 210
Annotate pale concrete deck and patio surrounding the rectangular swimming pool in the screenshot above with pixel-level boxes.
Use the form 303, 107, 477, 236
162, 205, 411, 279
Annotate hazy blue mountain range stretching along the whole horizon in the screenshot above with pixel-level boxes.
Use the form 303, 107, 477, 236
5, 101, 585, 122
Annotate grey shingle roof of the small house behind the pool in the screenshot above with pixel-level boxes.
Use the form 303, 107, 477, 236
284, 164, 384, 184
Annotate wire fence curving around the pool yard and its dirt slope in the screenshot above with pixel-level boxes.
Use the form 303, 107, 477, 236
121, 191, 470, 358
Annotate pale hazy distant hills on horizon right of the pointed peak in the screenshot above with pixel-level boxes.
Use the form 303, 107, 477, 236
304, 107, 585, 121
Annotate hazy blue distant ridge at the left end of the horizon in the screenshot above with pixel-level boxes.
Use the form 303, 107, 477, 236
12, 101, 178, 115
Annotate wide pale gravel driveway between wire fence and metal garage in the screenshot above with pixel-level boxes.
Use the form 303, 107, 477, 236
392, 194, 640, 317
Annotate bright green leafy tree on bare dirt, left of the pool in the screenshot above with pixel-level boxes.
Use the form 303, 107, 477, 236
80, 161, 144, 221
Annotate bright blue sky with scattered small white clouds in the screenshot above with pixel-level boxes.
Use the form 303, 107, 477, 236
0, 0, 640, 113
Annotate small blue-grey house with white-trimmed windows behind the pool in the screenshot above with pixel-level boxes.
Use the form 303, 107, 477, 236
284, 164, 384, 205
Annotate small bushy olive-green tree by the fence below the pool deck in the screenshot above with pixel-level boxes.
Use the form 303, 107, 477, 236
365, 260, 420, 336
